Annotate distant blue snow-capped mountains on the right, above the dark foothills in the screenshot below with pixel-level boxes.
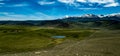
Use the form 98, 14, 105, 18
61, 13, 120, 22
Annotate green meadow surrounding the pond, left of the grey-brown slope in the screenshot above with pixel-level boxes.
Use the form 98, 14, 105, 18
0, 26, 95, 53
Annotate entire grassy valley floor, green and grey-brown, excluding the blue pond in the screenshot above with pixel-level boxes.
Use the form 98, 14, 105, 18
0, 25, 120, 56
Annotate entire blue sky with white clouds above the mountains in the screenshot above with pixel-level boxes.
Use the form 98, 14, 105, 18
0, 0, 120, 20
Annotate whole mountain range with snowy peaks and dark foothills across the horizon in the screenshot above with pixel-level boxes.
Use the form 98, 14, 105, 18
0, 13, 120, 29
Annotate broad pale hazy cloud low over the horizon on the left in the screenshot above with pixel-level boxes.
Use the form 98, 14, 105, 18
0, 12, 54, 20
